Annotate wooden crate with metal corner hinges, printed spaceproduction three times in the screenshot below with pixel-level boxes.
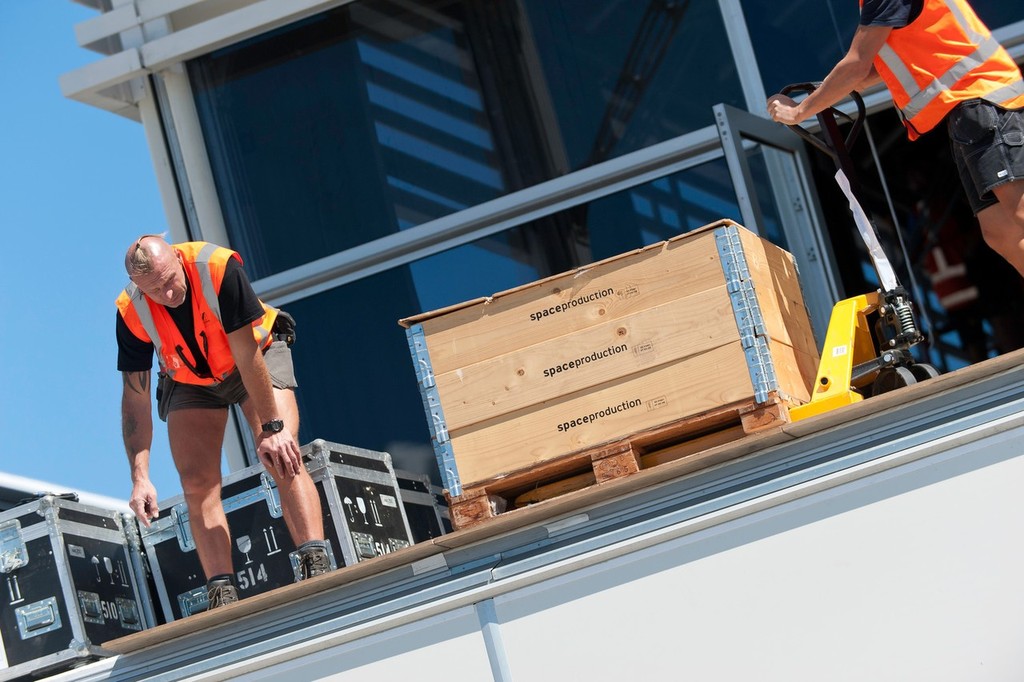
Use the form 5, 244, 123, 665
399, 220, 818, 497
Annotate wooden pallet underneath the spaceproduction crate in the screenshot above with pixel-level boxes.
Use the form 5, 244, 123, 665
445, 392, 791, 530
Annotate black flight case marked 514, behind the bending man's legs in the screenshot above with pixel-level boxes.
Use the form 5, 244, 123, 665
140, 440, 411, 622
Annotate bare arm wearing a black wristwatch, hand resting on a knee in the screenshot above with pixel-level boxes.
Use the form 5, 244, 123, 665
227, 327, 302, 476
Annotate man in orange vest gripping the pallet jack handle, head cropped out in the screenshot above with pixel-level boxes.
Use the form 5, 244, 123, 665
768, 0, 1024, 276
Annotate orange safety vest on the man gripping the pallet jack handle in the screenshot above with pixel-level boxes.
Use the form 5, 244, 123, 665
861, 0, 1024, 139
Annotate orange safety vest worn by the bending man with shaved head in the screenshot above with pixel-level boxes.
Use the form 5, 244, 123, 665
117, 242, 278, 386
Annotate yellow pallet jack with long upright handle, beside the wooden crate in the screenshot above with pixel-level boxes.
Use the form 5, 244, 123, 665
782, 83, 939, 421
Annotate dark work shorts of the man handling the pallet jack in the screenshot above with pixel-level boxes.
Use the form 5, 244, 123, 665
946, 99, 1024, 215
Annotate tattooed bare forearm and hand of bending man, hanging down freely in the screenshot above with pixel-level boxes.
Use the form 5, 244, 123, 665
121, 370, 160, 526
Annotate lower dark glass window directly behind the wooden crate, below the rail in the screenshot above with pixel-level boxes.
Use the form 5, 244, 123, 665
283, 159, 739, 482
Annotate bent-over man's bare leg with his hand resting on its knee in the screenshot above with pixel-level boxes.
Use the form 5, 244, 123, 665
242, 388, 324, 547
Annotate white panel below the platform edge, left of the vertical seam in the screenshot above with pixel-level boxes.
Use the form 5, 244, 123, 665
224, 606, 493, 682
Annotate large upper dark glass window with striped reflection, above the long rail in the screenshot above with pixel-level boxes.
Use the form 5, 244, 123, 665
188, 0, 742, 279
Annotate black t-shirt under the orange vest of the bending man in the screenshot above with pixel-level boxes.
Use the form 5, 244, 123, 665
116, 258, 263, 374
